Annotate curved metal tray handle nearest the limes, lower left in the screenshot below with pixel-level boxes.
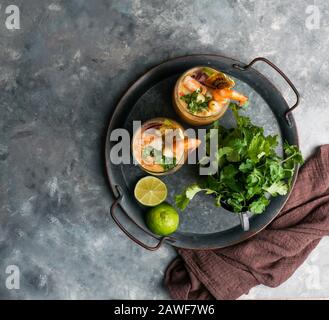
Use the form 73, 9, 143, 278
110, 185, 176, 251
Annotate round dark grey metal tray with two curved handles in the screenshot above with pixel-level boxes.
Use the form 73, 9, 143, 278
105, 55, 299, 250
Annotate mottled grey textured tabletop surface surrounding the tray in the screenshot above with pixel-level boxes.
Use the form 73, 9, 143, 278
0, 0, 329, 299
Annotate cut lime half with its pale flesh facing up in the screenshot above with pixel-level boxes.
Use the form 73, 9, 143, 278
134, 176, 168, 207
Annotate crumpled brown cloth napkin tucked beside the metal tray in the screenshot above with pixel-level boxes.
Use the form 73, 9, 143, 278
165, 145, 329, 299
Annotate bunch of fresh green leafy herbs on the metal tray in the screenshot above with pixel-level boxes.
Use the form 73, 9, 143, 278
176, 104, 303, 214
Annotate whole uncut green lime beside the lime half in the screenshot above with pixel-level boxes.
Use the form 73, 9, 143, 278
146, 202, 179, 236
